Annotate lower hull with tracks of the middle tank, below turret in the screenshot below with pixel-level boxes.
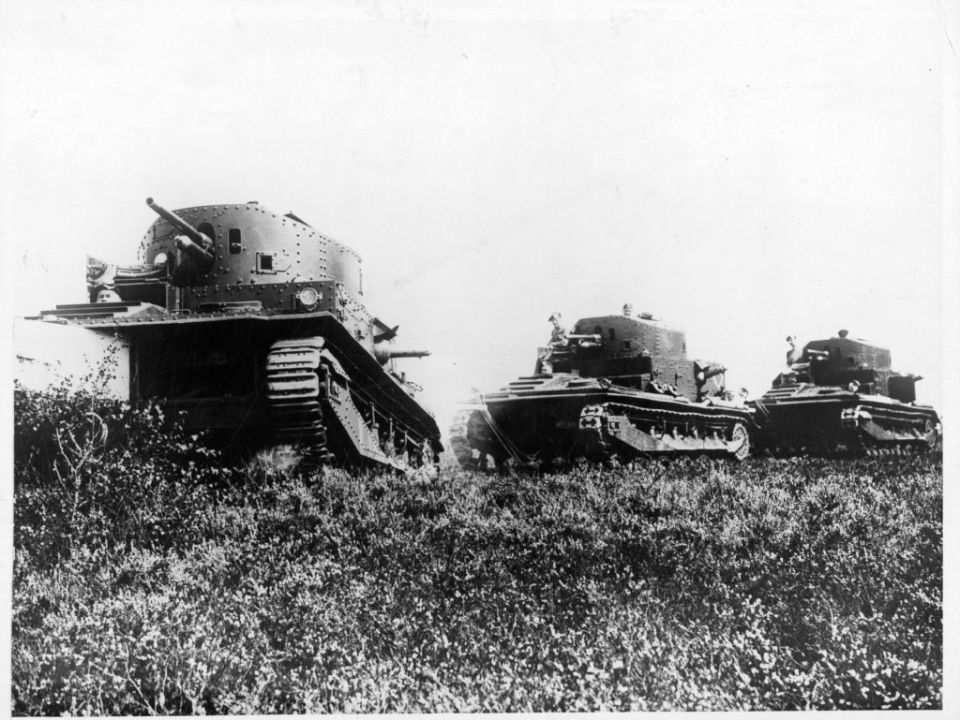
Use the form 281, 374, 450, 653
451, 374, 752, 469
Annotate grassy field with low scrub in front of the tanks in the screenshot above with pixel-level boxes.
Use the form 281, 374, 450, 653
12, 391, 942, 714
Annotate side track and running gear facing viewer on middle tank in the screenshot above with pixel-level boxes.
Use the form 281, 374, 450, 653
580, 402, 750, 463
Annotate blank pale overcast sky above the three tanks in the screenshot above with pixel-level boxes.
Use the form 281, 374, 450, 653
0, 0, 960, 434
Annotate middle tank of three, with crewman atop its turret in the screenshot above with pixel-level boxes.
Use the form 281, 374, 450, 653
450, 306, 754, 470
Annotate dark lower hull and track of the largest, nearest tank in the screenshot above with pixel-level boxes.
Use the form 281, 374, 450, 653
33, 303, 441, 470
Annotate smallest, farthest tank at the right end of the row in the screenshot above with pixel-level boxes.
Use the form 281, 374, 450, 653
750, 330, 941, 455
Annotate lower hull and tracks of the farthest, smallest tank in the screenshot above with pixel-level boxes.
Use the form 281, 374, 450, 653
751, 383, 941, 455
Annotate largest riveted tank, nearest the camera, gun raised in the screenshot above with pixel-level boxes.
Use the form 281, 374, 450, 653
29, 199, 441, 471
